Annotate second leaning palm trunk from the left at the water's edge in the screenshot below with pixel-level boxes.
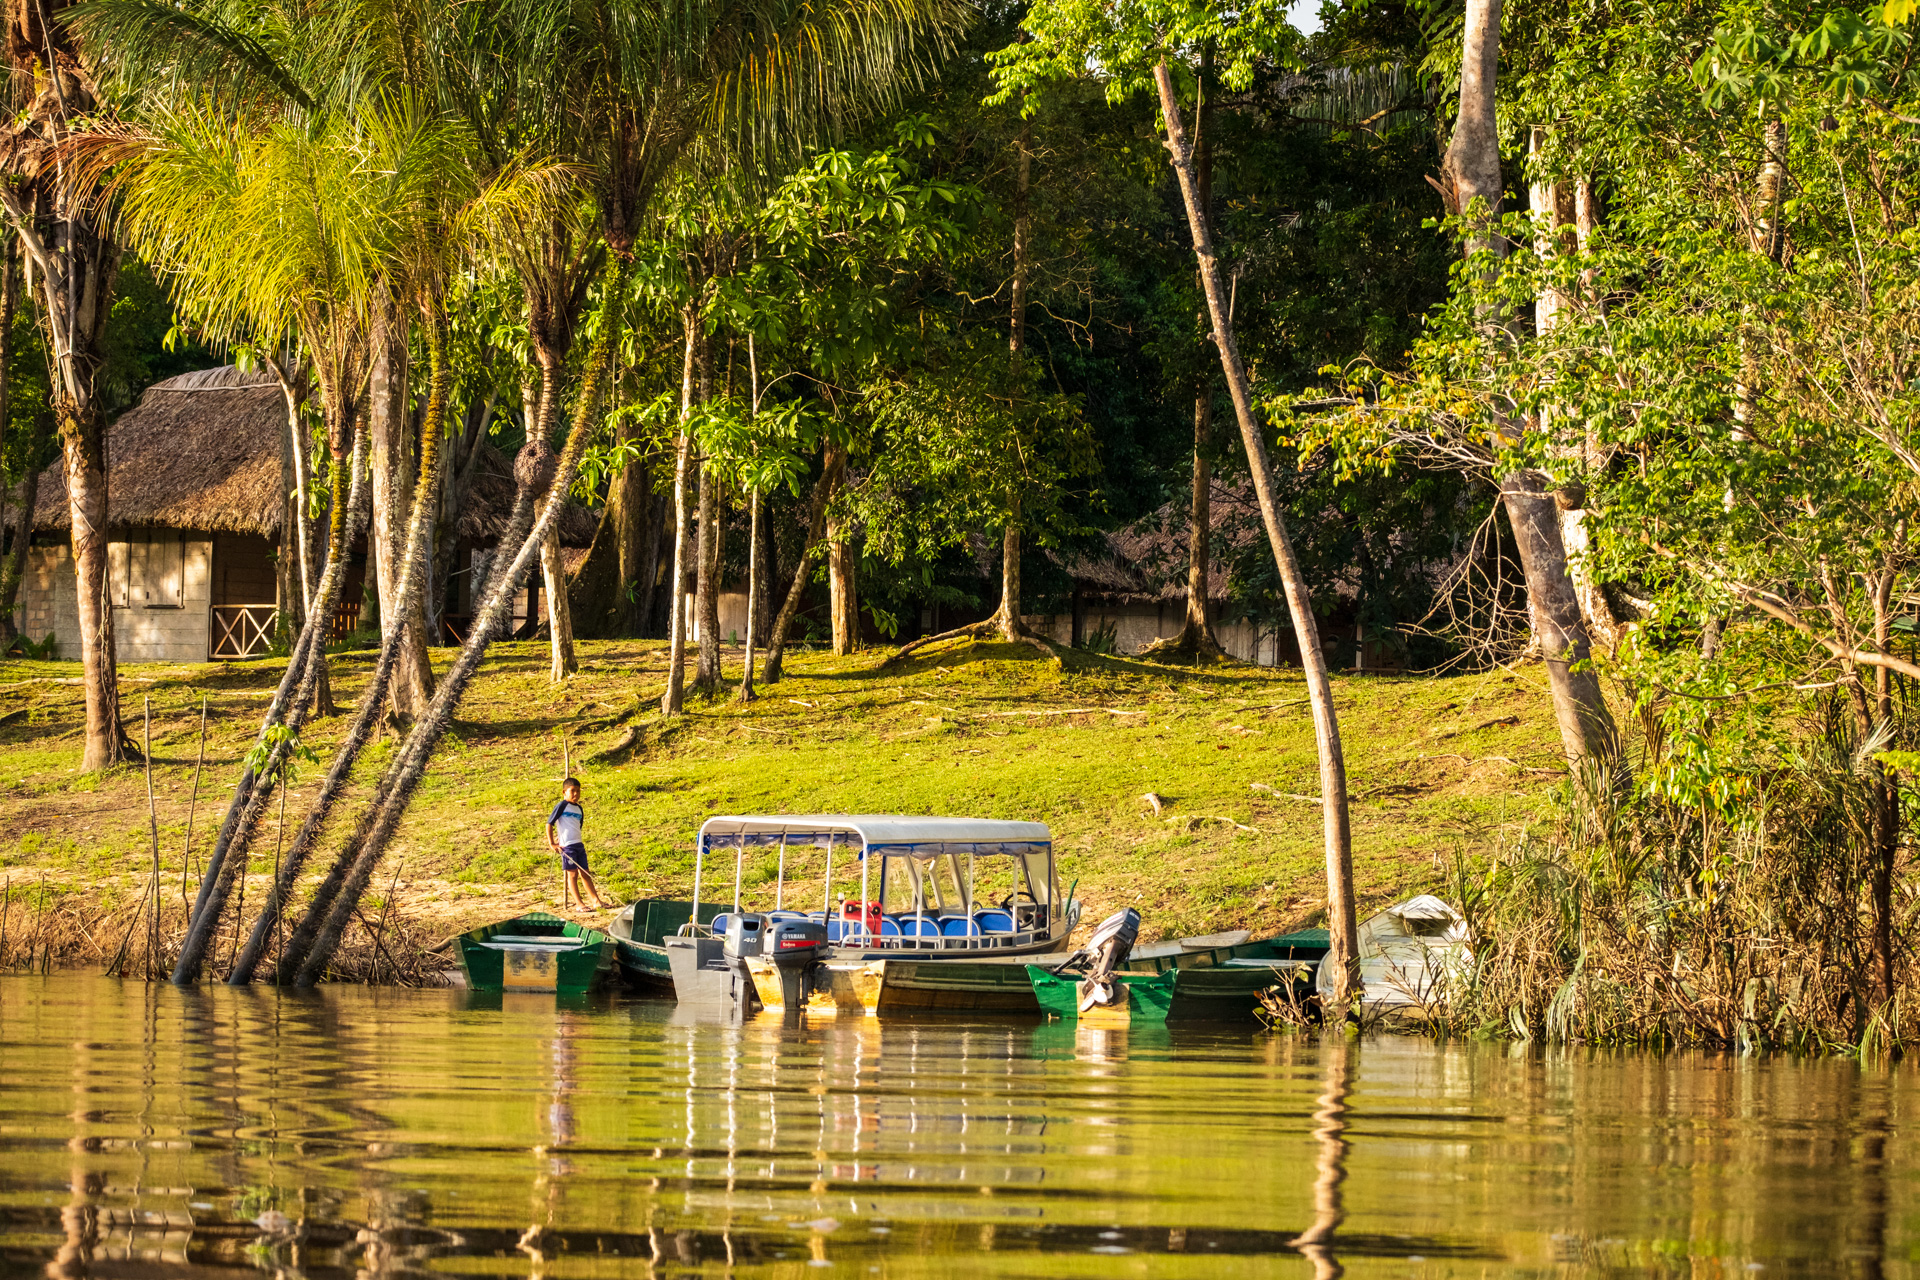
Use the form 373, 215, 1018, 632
227, 303, 453, 986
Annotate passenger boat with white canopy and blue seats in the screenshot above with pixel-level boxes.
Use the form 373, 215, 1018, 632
611, 814, 1079, 986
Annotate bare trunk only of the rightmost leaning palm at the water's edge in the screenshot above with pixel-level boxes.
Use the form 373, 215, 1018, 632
280, 253, 628, 986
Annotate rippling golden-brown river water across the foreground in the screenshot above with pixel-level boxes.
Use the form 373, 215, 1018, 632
0, 975, 1920, 1280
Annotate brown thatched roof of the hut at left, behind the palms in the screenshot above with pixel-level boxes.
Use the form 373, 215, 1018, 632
33, 365, 595, 547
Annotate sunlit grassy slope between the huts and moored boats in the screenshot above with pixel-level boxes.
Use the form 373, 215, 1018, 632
0, 641, 1559, 961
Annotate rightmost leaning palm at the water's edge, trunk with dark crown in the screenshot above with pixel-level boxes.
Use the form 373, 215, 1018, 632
280, 0, 966, 984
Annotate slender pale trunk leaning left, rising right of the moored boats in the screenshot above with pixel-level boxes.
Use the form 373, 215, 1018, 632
1154, 59, 1359, 1002
